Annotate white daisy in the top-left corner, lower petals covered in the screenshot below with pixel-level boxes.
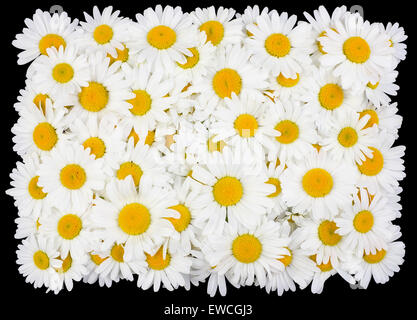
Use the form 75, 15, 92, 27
12, 9, 79, 64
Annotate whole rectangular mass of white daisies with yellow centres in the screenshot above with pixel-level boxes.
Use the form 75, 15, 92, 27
7, 5, 407, 296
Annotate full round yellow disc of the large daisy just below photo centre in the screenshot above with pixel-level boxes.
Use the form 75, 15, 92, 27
213, 176, 243, 206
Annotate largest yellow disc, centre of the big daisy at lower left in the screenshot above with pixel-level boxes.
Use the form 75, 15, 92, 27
117, 203, 151, 236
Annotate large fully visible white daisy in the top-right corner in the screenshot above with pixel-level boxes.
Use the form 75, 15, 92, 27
319, 14, 393, 88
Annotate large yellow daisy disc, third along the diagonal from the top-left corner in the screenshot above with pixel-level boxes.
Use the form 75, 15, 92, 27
78, 81, 109, 112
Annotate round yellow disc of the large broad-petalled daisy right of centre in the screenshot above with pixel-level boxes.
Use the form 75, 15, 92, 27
302, 168, 333, 198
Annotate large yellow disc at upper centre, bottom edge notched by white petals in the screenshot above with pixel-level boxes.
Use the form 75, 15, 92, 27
212, 68, 242, 99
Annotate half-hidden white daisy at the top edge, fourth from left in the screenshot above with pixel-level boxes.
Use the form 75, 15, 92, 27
190, 6, 243, 47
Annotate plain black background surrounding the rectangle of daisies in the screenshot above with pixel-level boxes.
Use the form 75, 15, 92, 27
0, 0, 417, 319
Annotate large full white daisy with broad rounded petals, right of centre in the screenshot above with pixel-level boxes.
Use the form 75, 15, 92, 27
281, 151, 357, 218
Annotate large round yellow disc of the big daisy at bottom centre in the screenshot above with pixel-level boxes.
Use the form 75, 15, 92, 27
232, 234, 262, 263
